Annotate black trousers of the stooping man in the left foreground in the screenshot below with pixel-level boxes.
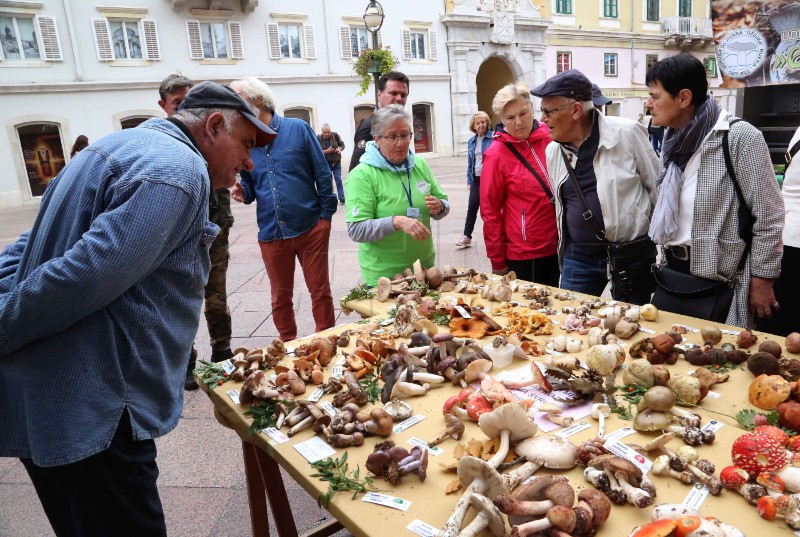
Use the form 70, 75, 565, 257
20, 410, 167, 537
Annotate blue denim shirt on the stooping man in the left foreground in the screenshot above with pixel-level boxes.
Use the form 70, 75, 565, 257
0, 119, 219, 466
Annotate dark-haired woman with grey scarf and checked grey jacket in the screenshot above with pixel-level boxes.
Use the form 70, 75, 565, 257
645, 54, 790, 327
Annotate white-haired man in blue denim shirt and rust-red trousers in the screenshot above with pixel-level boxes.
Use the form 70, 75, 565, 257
231, 78, 337, 341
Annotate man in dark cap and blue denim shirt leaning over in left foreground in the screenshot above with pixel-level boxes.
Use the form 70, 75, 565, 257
0, 82, 274, 536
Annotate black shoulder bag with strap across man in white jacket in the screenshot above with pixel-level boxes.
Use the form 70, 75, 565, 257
560, 149, 657, 302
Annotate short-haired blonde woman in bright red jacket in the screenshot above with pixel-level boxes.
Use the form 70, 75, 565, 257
481, 84, 559, 286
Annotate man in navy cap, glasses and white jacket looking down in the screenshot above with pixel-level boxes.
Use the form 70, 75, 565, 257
531, 69, 659, 304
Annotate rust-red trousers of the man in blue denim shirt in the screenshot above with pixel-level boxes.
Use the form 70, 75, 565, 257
258, 218, 336, 341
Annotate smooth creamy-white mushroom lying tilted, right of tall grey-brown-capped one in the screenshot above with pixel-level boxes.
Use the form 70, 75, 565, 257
503, 435, 578, 490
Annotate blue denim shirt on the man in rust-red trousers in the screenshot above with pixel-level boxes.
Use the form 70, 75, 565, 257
241, 114, 338, 242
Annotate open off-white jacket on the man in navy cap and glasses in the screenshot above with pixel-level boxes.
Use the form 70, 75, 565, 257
547, 113, 661, 262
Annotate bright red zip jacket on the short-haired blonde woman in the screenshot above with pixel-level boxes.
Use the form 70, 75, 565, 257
481, 122, 558, 270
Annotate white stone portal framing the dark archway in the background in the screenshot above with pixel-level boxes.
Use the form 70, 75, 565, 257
442, 13, 548, 155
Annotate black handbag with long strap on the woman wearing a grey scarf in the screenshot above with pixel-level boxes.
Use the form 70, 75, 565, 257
651, 119, 753, 323
